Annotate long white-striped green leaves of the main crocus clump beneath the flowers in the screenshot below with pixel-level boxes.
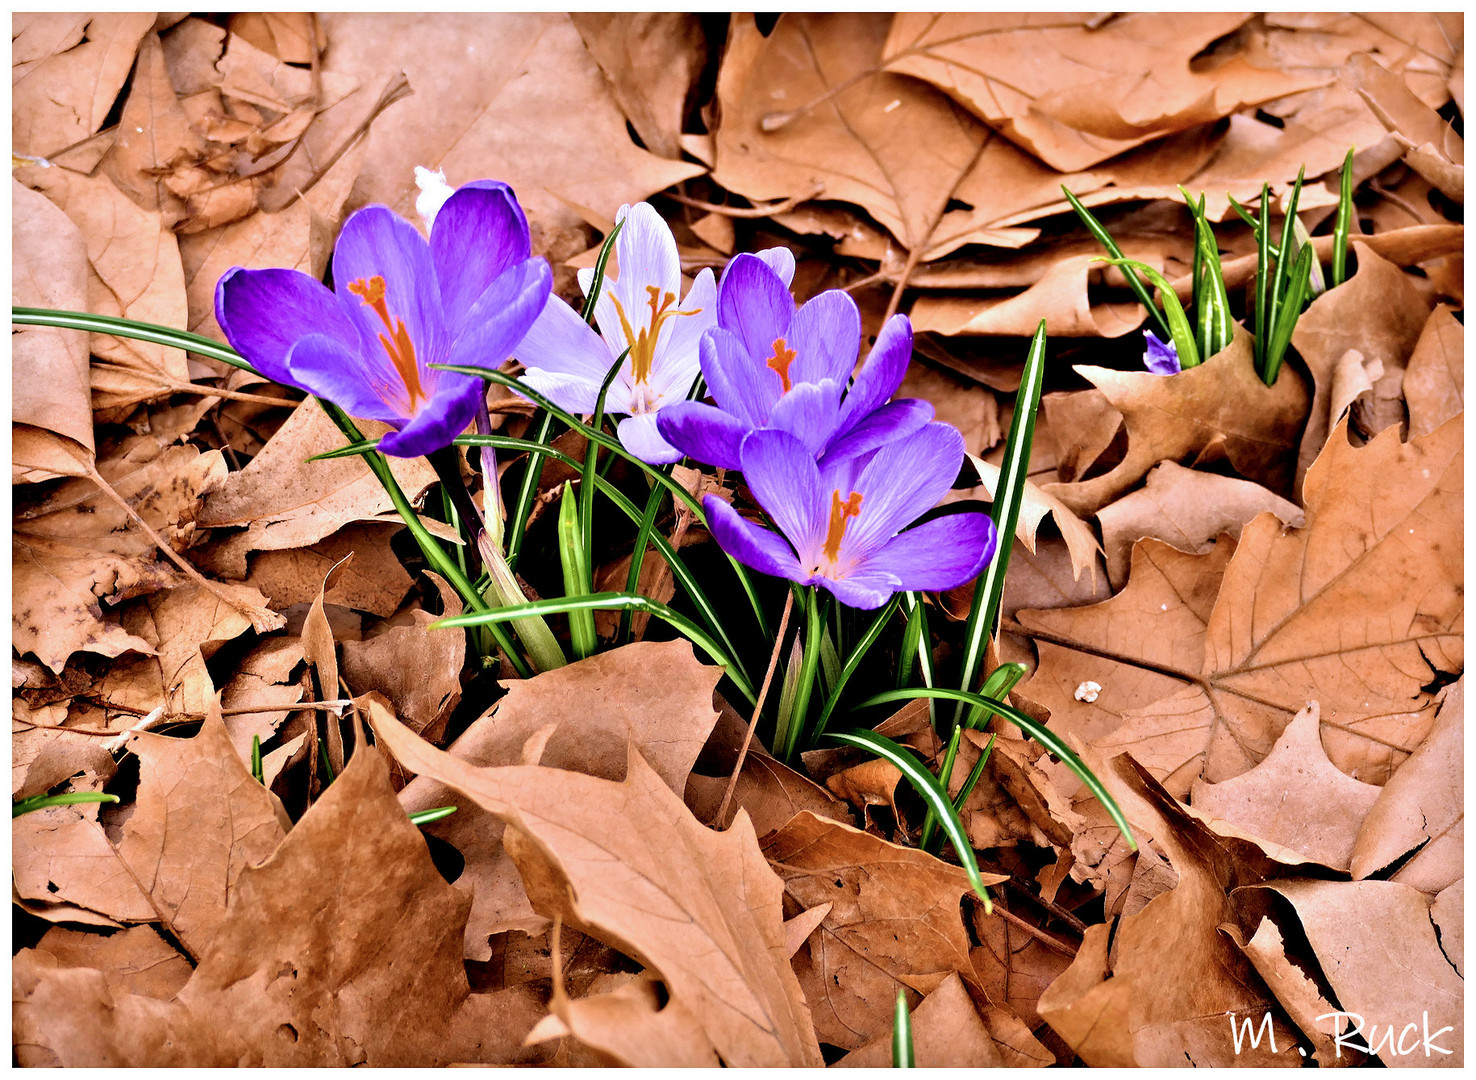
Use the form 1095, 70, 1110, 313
12, 221, 1133, 906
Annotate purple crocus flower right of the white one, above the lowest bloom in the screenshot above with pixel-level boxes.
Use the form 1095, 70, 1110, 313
657, 255, 933, 469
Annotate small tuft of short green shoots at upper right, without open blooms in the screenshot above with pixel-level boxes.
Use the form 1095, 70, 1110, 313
1061, 149, 1353, 387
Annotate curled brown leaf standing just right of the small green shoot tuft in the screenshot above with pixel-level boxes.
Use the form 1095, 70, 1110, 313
1283, 240, 1430, 489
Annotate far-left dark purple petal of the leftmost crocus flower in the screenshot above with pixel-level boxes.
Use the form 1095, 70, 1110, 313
215, 266, 359, 387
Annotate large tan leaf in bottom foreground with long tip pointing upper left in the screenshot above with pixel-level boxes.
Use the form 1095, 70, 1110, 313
371, 705, 821, 1067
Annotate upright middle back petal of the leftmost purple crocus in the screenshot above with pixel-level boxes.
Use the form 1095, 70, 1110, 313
334, 207, 447, 364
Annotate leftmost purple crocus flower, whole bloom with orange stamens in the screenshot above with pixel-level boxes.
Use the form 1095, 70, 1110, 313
215, 180, 554, 457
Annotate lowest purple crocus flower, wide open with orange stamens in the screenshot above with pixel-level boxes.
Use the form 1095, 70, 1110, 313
703, 423, 995, 608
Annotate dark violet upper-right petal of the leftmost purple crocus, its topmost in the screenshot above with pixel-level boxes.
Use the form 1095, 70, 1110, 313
431, 180, 528, 330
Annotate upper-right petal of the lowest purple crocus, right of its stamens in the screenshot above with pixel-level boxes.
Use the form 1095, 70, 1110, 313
840, 422, 964, 562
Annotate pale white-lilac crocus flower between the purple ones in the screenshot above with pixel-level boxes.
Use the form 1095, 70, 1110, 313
515, 202, 794, 465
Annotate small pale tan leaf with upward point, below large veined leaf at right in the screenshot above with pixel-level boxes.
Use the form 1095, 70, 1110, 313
1190, 701, 1382, 870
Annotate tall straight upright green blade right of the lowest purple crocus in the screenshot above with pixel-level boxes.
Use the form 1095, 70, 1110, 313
953, 320, 1050, 723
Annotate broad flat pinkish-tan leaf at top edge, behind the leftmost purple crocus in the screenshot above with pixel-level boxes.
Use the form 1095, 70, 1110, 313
302, 13, 703, 240
